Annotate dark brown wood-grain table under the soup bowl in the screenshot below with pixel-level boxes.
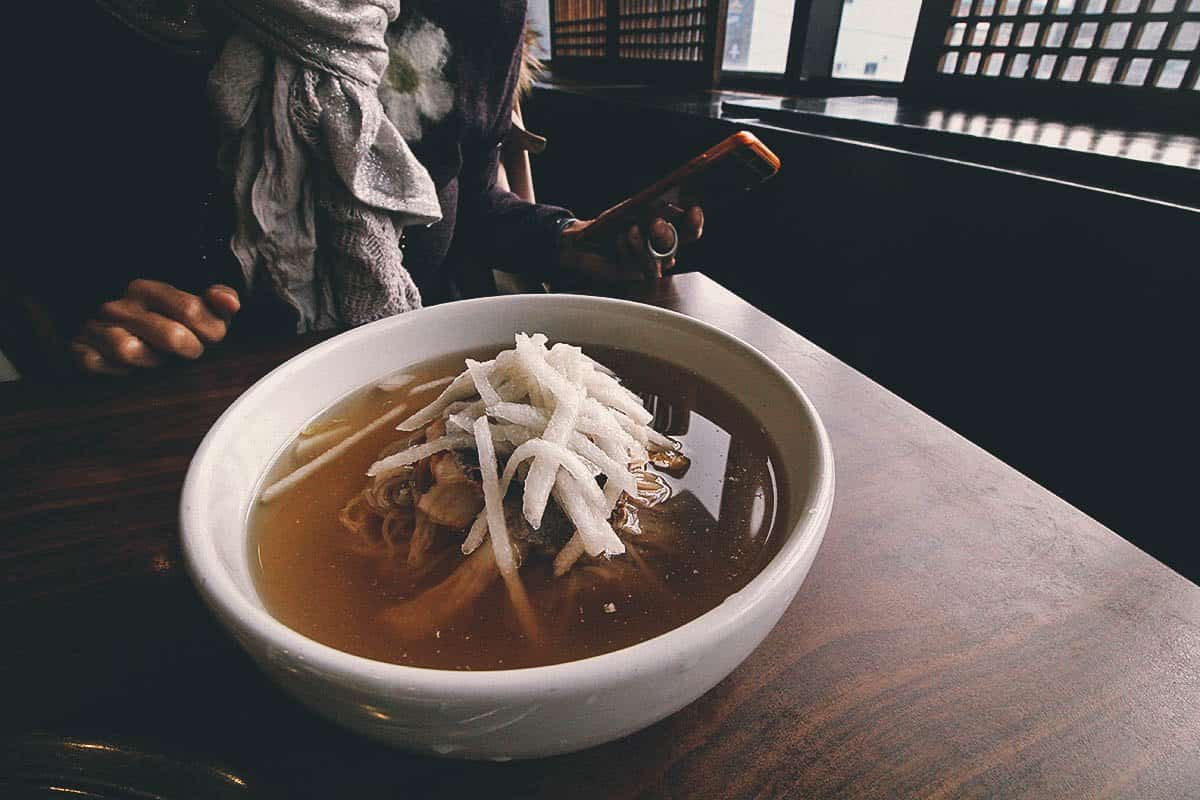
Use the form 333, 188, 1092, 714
0, 275, 1200, 798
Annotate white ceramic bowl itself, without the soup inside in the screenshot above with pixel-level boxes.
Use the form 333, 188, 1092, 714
180, 295, 834, 759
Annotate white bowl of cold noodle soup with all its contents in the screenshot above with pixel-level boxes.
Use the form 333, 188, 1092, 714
180, 295, 834, 759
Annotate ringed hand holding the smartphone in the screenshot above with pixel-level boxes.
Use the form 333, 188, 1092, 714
559, 205, 704, 281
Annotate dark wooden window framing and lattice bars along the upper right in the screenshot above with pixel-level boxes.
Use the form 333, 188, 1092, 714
550, 0, 1200, 133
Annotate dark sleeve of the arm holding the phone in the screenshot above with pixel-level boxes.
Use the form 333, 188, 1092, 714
460, 4, 572, 278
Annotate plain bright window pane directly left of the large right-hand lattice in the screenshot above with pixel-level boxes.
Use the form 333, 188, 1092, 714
830, 0, 921, 82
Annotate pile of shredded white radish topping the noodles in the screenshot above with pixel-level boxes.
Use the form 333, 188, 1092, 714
367, 333, 678, 578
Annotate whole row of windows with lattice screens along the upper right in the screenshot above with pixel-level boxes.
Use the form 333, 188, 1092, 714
544, 0, 1200, 122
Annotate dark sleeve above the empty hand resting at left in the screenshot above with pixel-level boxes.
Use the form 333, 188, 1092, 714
14, 4, 235, 337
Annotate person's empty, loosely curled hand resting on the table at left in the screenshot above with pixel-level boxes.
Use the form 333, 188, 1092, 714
71, 278, 241, 374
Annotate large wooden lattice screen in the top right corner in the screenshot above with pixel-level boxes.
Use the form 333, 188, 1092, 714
906, 0, 1200, 122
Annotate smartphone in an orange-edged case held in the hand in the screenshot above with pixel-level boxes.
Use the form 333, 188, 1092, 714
572, 131, 779, 248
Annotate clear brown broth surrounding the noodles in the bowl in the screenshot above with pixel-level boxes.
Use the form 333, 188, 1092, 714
248, 347, 787, 669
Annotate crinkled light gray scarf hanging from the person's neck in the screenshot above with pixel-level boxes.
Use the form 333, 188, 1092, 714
209, 0, 442, 332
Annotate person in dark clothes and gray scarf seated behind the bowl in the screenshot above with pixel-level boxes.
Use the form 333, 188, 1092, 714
42, 0, 703, 373
